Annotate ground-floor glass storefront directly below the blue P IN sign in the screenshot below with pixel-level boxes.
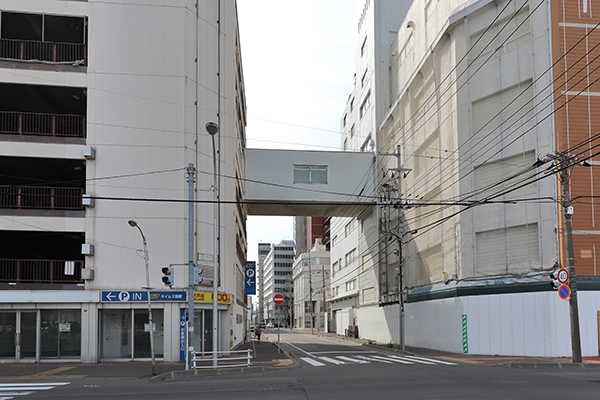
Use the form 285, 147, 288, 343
99, 309, 164, 359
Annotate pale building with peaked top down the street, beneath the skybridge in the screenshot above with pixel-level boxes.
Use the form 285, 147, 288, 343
292, 239, 331, 332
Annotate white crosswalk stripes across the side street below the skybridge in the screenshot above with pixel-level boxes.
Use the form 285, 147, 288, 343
300, 354, 457, 367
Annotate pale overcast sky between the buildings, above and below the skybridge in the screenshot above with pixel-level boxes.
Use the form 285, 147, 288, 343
237, 0, 356, 261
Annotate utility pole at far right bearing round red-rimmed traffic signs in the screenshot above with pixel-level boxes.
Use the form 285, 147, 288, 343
560, 169, 581, 363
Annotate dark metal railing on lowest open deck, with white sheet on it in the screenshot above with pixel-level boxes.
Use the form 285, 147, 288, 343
0, 259, 83, 283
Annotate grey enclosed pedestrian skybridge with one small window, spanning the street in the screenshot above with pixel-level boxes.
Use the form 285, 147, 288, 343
245, 149, 376, 217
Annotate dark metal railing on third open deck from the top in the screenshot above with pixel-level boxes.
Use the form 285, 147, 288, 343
0, 185, 83, 210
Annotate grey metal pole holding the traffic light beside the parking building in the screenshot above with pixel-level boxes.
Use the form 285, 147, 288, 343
186, 163, 196, 370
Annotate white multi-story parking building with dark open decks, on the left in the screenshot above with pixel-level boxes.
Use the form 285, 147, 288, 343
0, 0, 246, 362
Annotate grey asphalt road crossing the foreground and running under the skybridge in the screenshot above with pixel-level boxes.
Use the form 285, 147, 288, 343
7, 331, 600, 400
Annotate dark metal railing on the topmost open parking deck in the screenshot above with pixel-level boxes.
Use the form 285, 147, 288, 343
0, 39, 87, 65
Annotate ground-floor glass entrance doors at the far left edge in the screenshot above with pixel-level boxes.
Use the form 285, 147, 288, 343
0, 311, 37, 361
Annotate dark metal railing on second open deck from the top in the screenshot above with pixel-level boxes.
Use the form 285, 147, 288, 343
0, 111, 86, 138
